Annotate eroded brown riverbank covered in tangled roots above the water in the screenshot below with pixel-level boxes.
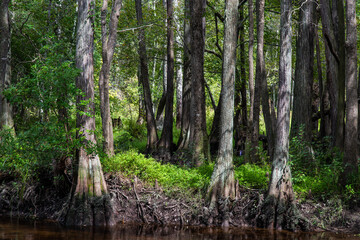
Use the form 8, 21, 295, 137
0, 172, 360, 234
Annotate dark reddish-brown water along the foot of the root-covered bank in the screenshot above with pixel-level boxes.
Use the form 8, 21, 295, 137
0, 219, 360, 240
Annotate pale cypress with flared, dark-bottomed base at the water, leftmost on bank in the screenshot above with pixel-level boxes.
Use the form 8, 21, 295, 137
65, 0, 114, 226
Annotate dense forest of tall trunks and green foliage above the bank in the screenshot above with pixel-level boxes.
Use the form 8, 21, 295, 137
0, 0, 360, 228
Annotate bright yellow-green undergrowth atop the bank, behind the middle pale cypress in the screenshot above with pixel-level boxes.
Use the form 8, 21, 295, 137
102, 150, 270, 192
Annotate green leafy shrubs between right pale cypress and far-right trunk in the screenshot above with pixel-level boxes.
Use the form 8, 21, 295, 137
290, 131, 343, 199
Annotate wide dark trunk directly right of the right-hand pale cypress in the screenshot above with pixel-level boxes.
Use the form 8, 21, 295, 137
291, 0, 315, 143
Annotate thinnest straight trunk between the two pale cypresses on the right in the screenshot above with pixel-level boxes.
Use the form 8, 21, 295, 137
245, 0, 256, 162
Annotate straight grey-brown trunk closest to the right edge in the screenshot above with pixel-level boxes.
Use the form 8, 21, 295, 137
343, 0, 358, 186
